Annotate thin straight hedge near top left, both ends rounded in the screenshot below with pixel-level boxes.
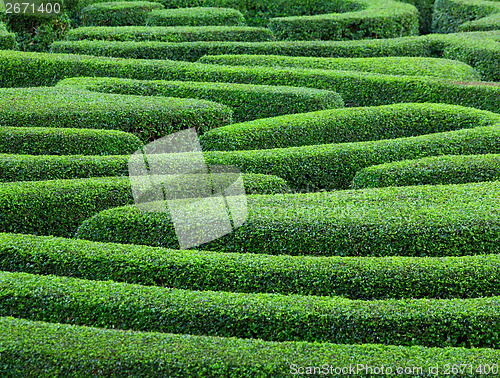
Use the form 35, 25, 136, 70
66, 26, 274, 43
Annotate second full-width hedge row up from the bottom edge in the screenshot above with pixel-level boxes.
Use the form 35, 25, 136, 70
0, 272, 500, 348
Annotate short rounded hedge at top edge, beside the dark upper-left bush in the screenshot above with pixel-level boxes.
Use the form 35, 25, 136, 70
80, 1, 163, 26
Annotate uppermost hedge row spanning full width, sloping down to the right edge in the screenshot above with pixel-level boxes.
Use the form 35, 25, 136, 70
11, 48, 500, 111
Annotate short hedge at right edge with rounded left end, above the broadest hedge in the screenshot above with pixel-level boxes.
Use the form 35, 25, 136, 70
352, 154, 500, 188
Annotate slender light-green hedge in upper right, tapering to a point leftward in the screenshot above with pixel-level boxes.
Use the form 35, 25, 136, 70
198, 55, 481, 81
